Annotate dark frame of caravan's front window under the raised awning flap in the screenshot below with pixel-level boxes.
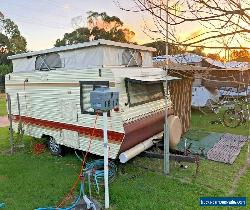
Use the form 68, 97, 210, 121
124, 77, 165, 107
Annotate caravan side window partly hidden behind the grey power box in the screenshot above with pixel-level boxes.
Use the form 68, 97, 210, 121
80, 81, 109, 114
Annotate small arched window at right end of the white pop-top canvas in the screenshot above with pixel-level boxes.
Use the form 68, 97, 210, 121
122, 49, 142, 67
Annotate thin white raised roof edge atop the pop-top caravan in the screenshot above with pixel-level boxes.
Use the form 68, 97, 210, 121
8, 39, 156, 59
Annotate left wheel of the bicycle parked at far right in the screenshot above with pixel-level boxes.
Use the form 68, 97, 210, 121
223, 109, 242, 128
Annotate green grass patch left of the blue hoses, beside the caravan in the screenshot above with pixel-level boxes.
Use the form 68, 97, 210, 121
0, 128, 79, 210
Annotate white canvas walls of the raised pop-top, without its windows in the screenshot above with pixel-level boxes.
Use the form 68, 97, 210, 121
10, 45, 153, 72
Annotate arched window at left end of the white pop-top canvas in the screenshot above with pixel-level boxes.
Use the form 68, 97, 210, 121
35, 53, 62, 71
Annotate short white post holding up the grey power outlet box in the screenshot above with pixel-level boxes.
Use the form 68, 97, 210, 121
103, 112, 109, 209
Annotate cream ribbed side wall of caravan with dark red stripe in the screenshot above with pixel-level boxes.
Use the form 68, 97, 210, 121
6, 69, 124, 158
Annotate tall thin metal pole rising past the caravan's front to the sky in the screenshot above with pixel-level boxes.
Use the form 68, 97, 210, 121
163, 0, 169, 175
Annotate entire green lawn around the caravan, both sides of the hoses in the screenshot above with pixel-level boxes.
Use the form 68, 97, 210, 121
0, 106, 250, 210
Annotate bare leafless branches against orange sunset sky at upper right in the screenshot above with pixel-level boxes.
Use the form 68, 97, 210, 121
117, 0, 250, 47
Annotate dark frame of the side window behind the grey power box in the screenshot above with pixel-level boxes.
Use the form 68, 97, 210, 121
79, 81, 110, 116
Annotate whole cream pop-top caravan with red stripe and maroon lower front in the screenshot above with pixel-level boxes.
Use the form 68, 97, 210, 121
5, 40, 181, 159
